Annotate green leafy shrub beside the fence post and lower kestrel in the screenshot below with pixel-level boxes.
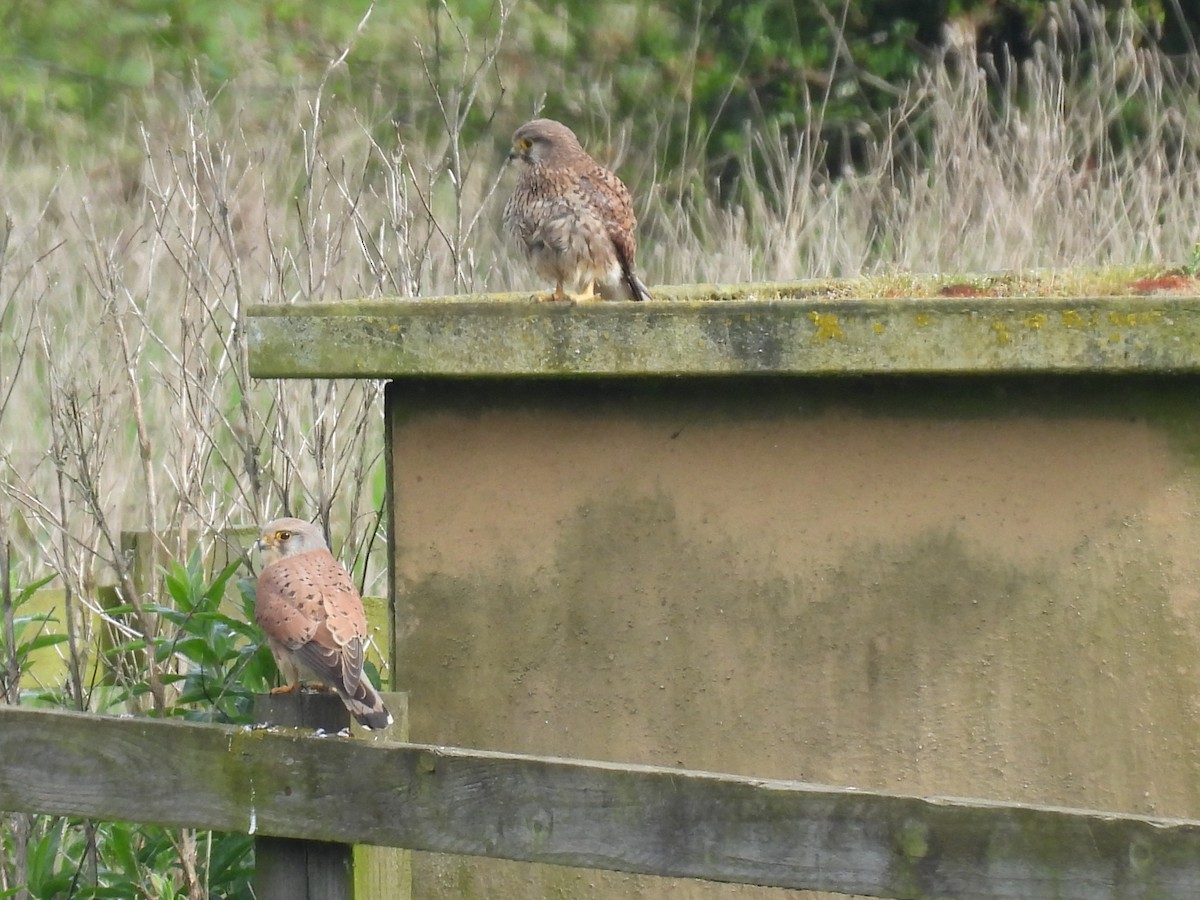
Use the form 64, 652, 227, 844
0, 551, 265, 900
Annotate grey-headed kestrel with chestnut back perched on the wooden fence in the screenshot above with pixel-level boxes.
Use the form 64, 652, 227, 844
254, 518, 391, 728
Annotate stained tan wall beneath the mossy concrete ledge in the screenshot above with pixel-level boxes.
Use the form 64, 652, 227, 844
388, 374, 1200, 900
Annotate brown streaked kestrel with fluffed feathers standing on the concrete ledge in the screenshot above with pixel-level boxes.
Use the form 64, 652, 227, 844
504, 119, 652, 300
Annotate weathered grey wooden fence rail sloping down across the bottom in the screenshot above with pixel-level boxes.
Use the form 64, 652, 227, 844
0, 707, 1200, 900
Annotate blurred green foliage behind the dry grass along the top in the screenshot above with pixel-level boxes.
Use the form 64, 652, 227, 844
0, 0, 1200, 182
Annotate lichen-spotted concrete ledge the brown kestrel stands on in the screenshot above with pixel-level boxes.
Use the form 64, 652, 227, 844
246, 290, 1200, 378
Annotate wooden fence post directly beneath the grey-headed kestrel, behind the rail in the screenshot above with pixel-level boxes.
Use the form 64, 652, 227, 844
254, 690, 412, 900
